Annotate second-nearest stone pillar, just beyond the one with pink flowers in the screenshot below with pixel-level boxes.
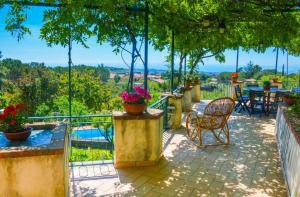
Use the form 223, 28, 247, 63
169, 94, 183, 129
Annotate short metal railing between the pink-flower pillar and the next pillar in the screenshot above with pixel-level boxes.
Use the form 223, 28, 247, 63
149, 96, 171, 131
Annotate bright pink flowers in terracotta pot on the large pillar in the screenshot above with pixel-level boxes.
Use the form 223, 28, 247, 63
121, 86, 151, 115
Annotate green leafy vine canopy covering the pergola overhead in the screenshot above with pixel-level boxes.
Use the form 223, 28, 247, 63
0, 0, 300, 71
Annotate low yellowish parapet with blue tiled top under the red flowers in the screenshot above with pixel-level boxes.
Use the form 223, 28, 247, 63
0, 123, 69, 196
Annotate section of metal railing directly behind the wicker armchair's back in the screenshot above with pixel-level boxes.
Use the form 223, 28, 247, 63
200, 81, 230, 100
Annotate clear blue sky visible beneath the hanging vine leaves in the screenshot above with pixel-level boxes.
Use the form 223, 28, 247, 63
0, 6, 300, 72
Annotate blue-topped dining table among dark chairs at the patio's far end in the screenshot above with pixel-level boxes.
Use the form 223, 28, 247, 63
244, 86, 291, 115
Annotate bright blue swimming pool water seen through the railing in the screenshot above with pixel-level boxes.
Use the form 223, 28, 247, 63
71, 128, 112, 140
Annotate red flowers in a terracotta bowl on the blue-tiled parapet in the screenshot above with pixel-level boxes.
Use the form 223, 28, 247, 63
0, 104, 32, 142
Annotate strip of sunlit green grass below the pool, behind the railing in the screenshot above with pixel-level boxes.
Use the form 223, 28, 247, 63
70, 147, 113, 162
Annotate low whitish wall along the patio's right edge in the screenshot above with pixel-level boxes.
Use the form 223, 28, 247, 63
275, 107, 300, 197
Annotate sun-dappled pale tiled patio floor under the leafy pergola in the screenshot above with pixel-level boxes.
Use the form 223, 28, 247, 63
70, 103, 286, 196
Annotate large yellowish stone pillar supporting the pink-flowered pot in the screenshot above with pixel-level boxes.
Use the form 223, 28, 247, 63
113, 109, 163, 168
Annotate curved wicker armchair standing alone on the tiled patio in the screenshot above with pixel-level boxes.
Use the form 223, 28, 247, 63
186, 97, 235, 146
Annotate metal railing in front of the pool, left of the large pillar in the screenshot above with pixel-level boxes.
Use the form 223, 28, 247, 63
29, 114, 114, 163
